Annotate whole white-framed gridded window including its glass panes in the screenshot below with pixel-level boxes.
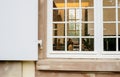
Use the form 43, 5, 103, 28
47, 0, 120, 58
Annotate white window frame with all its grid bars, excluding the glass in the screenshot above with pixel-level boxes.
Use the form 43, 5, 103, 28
47, 0, 120, 58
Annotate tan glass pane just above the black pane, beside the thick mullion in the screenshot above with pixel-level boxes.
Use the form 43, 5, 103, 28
104, 23, 116, 36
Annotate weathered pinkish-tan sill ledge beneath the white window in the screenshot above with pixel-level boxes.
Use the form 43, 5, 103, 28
37, 59, 120, 72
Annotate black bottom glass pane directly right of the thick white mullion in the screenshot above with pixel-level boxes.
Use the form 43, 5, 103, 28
104, 38, 116, 51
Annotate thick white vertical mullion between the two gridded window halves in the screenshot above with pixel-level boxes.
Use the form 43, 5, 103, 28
94, 0, 103, 55
